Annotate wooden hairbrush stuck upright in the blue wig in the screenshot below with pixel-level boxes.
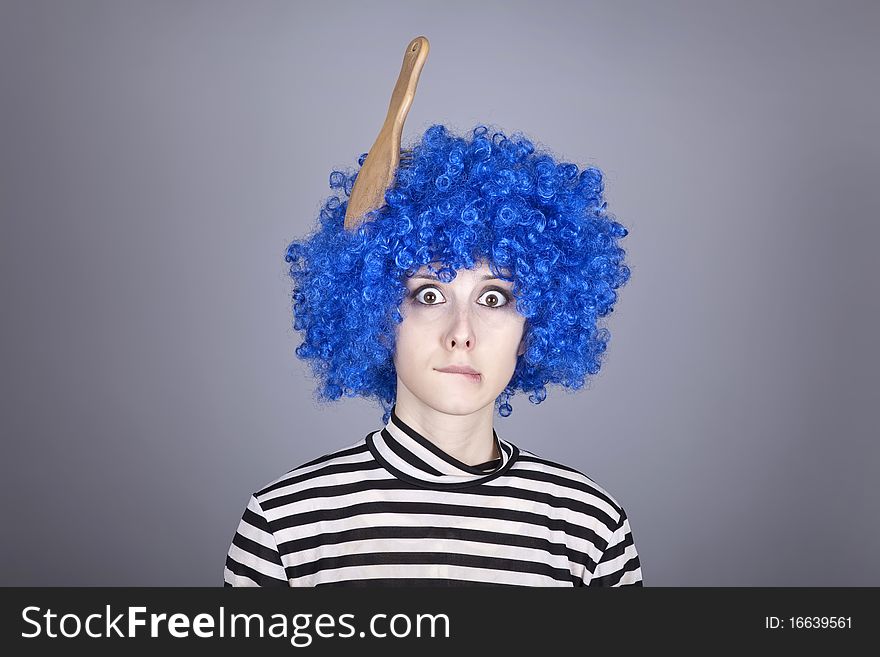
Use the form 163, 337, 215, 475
344, 36, 430, 230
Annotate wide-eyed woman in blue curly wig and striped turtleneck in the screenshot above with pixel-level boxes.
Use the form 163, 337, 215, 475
224, 120, 642, 586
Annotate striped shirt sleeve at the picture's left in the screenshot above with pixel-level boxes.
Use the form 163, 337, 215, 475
223, 495, 289, 586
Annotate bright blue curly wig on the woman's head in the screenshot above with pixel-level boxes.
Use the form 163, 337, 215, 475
285, 125, 630, 424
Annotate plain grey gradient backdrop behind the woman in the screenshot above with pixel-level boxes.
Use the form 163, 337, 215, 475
0, 0, 880, 586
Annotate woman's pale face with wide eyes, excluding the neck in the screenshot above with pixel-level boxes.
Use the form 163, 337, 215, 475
394, 262, 525, 415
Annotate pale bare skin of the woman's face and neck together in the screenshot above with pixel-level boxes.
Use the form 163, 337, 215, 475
394, 261, 525, 465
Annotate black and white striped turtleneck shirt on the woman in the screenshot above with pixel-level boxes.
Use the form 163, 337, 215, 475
224, 409, 642, 586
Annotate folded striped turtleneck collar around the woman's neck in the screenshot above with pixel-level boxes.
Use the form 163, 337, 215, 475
367, 405, 519, 489
